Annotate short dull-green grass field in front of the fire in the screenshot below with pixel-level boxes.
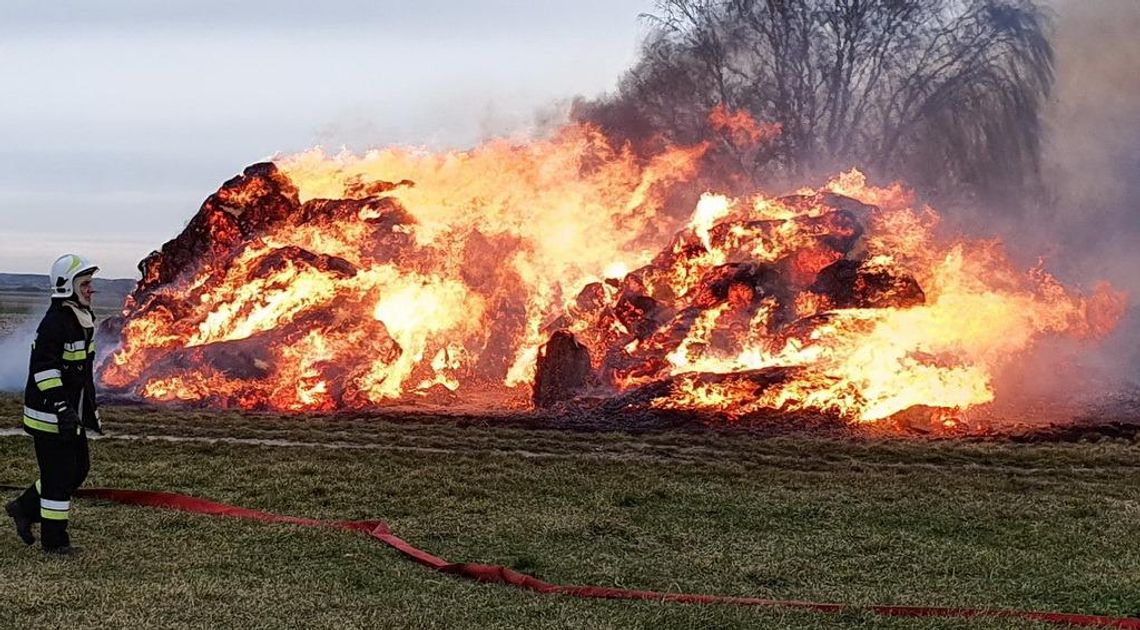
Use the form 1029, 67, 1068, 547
0, 396, 1140, 628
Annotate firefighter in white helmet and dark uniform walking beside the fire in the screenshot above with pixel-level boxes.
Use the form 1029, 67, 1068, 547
6, 254, 101, 556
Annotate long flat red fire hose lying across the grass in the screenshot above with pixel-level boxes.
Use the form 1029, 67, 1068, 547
44, 488, 1140, 630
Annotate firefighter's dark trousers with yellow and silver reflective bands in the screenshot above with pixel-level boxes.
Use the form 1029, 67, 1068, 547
17, 431, 91, 549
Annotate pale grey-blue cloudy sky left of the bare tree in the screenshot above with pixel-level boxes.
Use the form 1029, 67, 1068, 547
0, 0, 654, 278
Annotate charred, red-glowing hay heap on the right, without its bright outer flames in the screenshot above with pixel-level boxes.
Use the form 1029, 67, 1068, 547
535, 189, 925, 408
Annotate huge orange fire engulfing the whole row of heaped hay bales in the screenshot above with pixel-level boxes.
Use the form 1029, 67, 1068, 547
100, 117, 1124, 422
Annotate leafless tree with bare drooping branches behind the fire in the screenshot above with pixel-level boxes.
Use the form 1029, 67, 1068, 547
576, 0, 1053, 201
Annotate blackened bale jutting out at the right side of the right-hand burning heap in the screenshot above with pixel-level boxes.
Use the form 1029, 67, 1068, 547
808, 259, 926, 309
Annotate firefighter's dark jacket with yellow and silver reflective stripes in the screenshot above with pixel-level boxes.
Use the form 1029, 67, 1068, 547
24, 298, 99, 436
